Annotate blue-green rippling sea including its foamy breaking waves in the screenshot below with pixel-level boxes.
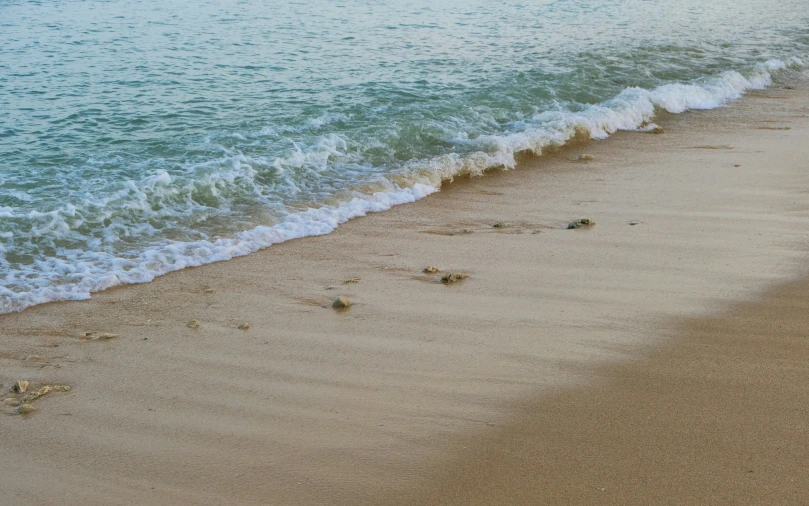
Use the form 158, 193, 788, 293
0, 0, 809, 313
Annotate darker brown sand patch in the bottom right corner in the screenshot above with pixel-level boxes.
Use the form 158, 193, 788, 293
390, 279, 809, 506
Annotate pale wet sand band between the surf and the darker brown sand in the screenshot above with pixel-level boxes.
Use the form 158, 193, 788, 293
0, 83, 809, 504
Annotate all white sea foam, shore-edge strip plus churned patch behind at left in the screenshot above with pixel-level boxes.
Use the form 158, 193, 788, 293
0, 58, 803, 313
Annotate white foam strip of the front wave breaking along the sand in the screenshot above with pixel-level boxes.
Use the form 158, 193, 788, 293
0, 57, 804, 313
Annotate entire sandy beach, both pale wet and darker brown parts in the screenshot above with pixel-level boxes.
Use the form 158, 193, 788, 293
0, 83, 809, 505
